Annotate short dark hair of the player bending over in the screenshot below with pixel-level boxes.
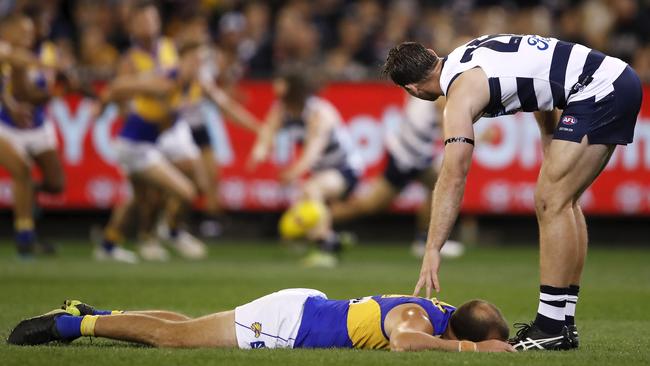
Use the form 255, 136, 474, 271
382, 42, 438, 86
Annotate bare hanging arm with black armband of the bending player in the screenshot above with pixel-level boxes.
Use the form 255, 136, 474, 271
414, 68, 490, 297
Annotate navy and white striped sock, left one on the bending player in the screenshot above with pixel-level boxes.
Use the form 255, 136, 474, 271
535, 285, 567, 334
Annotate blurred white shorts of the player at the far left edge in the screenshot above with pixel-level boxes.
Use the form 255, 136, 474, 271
0, 121, 59, 159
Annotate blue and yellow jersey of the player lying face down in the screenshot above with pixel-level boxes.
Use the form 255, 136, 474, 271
294, 295, 456, 349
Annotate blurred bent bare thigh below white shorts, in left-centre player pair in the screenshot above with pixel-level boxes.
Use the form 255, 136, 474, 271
134, 159, 196, 201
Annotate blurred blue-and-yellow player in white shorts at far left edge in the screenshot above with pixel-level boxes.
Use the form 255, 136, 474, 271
0, 13, 64, 256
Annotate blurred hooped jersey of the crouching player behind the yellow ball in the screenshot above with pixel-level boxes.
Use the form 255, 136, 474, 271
282, 97, 364, 174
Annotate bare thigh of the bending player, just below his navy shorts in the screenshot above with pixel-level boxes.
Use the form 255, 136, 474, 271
535, 137, 615, 209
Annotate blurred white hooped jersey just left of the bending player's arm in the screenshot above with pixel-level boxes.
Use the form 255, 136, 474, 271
386, 96, 440, 170
